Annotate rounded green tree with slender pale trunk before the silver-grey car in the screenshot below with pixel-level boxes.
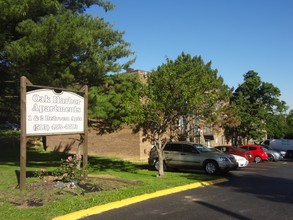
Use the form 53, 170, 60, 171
131, 53, 229, 176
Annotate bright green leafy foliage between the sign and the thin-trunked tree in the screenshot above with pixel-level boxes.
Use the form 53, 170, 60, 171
89, 73, 144, 135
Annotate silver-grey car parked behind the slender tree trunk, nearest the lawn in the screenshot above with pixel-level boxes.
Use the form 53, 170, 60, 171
148, 142, 238, 174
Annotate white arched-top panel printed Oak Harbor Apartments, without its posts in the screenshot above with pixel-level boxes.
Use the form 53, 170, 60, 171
26, 89, 84, 135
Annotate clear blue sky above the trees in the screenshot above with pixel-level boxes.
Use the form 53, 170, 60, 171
87, 0, 293, 109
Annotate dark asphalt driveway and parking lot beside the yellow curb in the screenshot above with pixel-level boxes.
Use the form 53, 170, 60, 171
81, 159, 293, 220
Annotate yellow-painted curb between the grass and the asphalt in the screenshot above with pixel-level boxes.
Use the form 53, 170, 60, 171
53, 178, 228, 220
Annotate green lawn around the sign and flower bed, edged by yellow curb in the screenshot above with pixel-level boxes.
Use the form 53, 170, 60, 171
0, 132, 217, 220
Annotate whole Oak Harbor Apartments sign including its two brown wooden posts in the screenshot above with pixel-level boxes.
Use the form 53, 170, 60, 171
19, 76, 88, 189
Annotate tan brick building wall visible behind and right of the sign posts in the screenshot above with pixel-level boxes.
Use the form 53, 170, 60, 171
47, 127, 151, 161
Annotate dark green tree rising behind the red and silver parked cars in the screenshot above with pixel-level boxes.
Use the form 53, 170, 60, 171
231, 71, 286, 141
